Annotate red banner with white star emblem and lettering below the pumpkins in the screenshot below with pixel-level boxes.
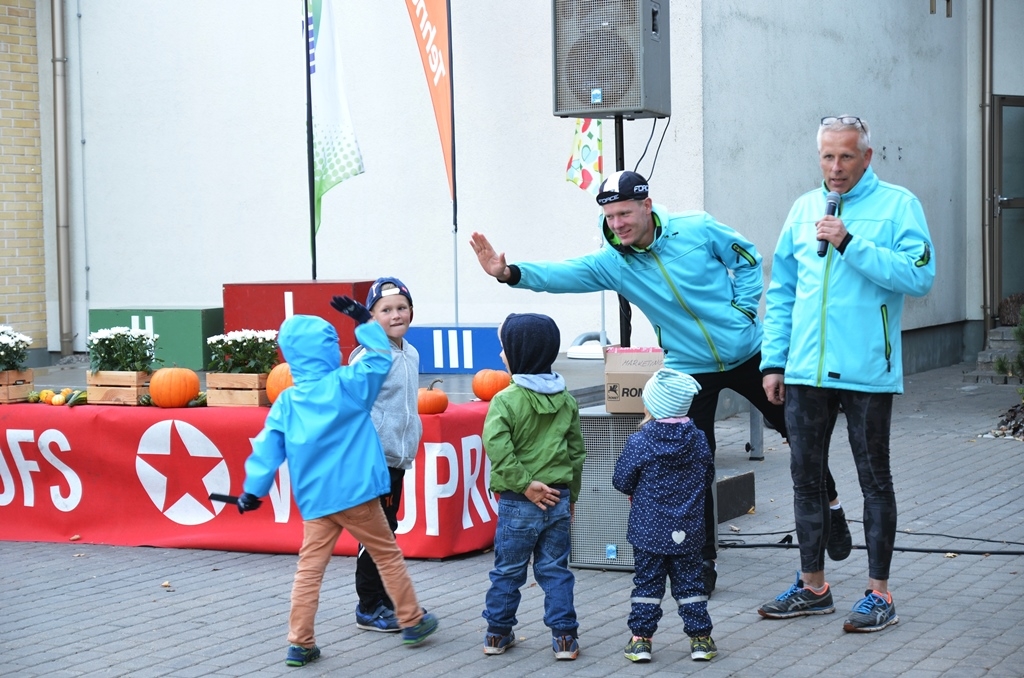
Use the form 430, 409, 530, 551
0, 402, 497, 558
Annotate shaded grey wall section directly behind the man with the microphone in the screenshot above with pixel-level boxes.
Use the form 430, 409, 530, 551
705, 0, 968, 329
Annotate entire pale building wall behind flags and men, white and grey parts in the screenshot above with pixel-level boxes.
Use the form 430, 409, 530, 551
37, 0, 1007, 350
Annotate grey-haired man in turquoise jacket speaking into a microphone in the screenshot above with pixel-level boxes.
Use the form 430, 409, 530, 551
758, 116, 935, 632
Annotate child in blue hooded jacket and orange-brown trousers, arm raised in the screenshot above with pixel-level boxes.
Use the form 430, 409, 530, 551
239, 297, 437, 666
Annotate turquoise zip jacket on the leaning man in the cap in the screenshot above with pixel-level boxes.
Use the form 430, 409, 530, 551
515, 205, 764, 374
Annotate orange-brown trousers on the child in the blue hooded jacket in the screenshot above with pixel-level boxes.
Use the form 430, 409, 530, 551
288, 499, 423, 647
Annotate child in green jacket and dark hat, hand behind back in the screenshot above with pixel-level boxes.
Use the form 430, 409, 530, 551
483, 313, 587, 660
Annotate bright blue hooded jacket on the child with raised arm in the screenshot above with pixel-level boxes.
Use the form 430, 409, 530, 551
243, 315, 391, 520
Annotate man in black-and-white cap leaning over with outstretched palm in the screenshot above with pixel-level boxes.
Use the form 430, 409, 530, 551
470, 171, 849, 595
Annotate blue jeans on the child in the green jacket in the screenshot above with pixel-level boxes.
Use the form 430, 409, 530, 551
483, 490, 580, 636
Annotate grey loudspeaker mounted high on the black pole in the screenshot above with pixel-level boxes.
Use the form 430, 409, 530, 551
551, 0, 672, 119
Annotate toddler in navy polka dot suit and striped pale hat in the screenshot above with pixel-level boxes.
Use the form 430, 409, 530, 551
611, 368, 717, 662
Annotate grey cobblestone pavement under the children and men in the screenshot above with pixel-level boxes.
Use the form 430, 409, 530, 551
0, 365, 1024, 678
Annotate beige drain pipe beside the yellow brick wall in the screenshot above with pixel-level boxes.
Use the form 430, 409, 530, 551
50, 0, 75, 357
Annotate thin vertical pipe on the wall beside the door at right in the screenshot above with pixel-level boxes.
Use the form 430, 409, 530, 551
981, 0, 998, 331
